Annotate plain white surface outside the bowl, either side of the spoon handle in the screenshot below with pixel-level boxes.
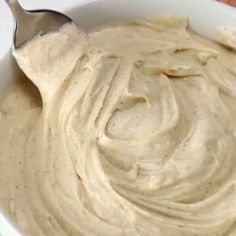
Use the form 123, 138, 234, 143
0, 0, 86, 57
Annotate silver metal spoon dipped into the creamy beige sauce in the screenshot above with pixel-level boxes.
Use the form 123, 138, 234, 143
5, 0, 72, 49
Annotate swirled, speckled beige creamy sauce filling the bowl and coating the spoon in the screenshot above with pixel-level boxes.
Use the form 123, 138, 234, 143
0, 17, 236, 236
